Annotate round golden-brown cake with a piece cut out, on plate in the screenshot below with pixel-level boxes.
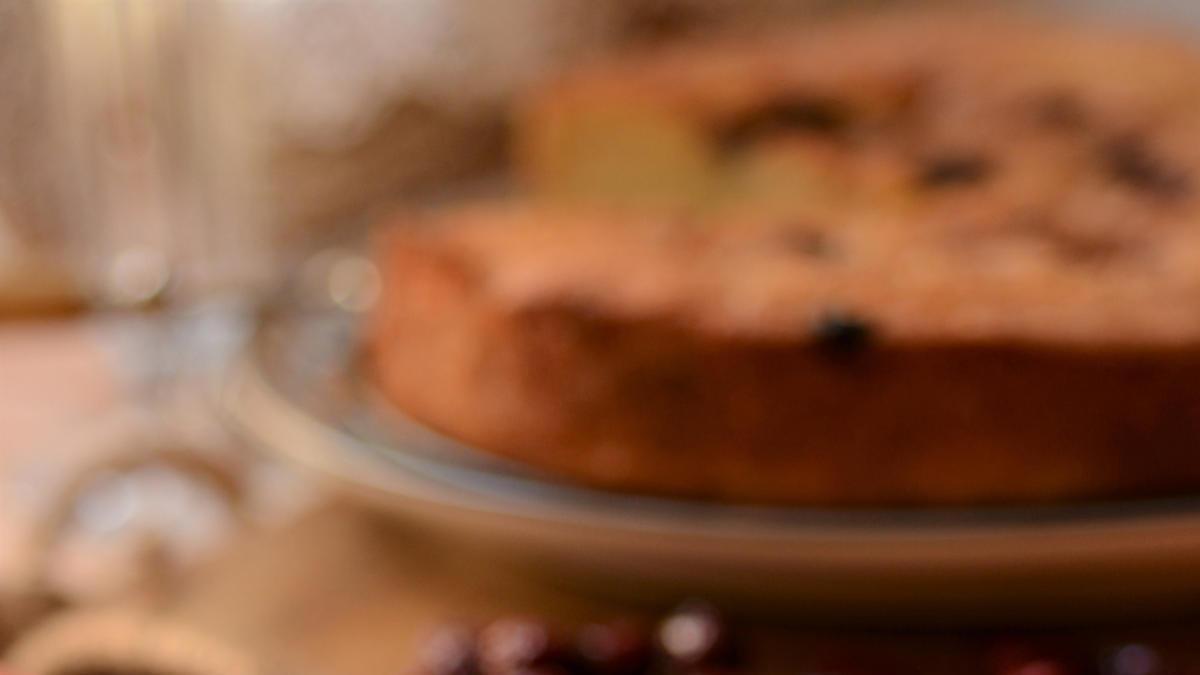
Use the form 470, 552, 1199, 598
367, 16, 1200, 506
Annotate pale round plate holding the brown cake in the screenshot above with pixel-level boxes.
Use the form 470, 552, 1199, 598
220, 257, 1200, 623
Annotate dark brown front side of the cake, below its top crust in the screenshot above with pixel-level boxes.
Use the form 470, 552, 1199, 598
370, 209, 1200, 504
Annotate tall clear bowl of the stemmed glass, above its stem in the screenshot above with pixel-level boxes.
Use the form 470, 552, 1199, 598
42, 0, 270, 307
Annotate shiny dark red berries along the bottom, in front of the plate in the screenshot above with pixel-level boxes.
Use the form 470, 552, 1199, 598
416, 602, 1171, 675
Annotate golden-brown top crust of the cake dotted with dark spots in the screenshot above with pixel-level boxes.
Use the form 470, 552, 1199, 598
388, 14, 1200, 347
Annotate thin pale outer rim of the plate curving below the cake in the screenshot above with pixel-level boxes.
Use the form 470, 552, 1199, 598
217, 331, 1200, 561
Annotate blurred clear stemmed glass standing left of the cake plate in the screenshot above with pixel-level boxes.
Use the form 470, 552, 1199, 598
32, 0, 276, 598
